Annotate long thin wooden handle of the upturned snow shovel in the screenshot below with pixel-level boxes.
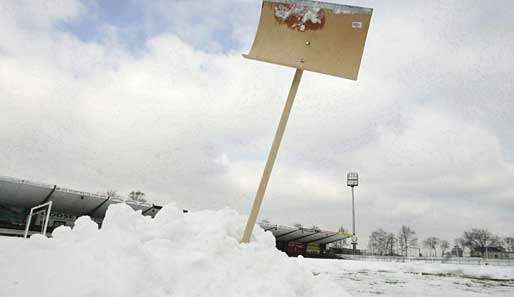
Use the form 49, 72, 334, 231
241, 69, 303, 243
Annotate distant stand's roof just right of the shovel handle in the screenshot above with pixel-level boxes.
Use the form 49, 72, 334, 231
259, 222, 352, 244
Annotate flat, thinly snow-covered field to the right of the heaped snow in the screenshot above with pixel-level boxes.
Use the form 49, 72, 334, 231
298, 258, 514, 297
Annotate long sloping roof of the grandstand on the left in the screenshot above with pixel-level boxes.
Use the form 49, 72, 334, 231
0, 176, 161, 218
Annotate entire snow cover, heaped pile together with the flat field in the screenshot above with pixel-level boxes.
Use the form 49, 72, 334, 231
0, 204, 514, 297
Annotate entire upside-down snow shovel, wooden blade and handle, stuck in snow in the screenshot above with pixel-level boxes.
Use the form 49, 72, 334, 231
241, 0, 373, 242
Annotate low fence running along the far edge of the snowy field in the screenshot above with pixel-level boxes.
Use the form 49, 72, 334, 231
337, 255, 514, 266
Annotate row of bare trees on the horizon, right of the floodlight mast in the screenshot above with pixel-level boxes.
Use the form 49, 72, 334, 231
368, 226, 514, 257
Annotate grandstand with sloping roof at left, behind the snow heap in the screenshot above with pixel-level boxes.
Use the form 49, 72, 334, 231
0, 177, 162, 236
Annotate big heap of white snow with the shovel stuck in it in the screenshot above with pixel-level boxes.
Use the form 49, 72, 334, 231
0, 204, 347, 297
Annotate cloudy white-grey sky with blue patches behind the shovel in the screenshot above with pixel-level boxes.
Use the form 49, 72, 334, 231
0, 0, 514, 243
